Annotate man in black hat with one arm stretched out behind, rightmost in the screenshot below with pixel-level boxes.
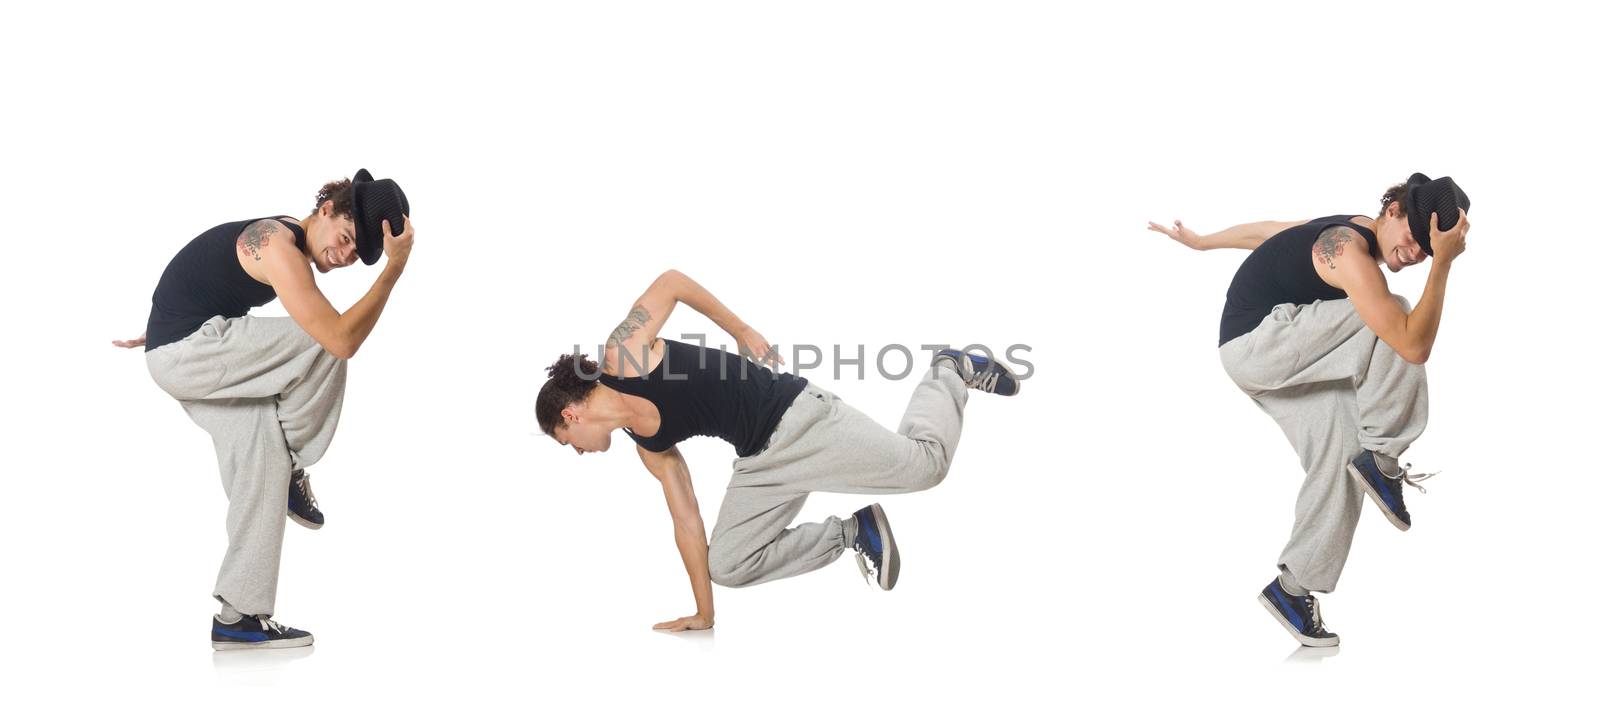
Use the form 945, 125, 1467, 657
1150, 173, 1470, 647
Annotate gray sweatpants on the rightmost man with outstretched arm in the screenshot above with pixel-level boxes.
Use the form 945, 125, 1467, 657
1221, 295, 1427, 592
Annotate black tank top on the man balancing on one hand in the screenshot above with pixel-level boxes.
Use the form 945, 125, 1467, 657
600, 339, 806, 456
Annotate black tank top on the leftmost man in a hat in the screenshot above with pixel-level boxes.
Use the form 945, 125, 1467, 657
144, 216, 306, 352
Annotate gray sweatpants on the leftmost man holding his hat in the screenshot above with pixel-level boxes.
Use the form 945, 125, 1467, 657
146, 315, 346, 615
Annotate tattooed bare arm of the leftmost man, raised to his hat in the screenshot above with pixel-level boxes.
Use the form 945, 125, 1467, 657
251, 219, 413, 360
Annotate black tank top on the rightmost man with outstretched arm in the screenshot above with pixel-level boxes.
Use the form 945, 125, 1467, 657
1218, 216, 1378, 346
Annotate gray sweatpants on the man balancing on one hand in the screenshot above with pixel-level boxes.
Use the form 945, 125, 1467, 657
710, 365, 966, 588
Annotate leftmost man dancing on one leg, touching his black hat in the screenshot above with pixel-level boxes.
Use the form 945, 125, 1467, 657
112, 170, 413, 650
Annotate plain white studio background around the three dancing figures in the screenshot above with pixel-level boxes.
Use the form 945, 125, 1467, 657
0, 2, 1600, 711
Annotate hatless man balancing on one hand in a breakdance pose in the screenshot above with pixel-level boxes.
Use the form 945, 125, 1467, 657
534, 271, 1019, 632
